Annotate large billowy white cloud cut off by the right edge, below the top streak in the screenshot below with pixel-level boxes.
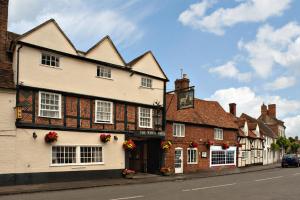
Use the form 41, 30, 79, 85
238, 22, 300, 78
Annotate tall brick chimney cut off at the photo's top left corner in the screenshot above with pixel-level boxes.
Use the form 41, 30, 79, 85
0, 0, 8, 63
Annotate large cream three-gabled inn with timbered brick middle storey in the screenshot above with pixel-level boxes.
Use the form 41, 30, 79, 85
0, 0, 168, 184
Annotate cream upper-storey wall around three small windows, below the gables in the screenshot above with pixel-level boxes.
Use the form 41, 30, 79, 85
14, 46, 164, 105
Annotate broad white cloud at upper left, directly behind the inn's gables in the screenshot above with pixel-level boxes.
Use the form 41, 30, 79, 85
9, 0, 143, 50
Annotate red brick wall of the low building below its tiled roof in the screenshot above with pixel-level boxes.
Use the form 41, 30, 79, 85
165, 122, 237, 173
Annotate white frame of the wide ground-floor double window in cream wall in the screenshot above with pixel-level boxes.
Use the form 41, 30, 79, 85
50, 144, 105, 167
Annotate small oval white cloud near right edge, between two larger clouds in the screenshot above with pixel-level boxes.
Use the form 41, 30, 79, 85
265, 76, 296, 90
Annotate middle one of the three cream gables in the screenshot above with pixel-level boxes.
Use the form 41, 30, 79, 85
85, 36, 126, 66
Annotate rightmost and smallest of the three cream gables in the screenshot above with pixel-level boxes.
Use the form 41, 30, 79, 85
128, 51, 167, 79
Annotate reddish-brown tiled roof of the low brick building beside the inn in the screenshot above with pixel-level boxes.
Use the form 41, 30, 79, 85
166, 94, 238, 129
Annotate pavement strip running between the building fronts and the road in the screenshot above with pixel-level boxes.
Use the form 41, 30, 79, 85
0, 164, 280, 196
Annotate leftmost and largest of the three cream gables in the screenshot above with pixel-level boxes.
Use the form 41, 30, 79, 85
17, 19, 77, 55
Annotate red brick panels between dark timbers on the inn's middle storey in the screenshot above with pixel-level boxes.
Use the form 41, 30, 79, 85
19, 89, 162, 131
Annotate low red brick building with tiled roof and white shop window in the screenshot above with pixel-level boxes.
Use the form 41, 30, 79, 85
165, 76, 238, 173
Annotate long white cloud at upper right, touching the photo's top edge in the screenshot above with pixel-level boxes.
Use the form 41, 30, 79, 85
178, 0, 291, 35
